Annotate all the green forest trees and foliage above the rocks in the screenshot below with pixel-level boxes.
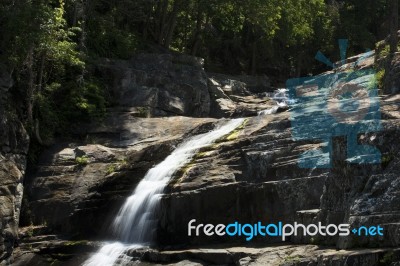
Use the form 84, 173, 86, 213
0, 0, 391, 148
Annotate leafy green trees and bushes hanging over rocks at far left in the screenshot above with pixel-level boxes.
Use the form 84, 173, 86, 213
0, 0, 106, 143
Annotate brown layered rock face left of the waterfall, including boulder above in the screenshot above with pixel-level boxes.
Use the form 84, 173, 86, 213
23, 54, 282, 247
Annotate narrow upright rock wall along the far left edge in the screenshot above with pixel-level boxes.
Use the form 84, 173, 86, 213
0, 66, 29, 265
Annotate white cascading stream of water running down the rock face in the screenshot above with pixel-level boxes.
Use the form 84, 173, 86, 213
83, 118, 244, 266
